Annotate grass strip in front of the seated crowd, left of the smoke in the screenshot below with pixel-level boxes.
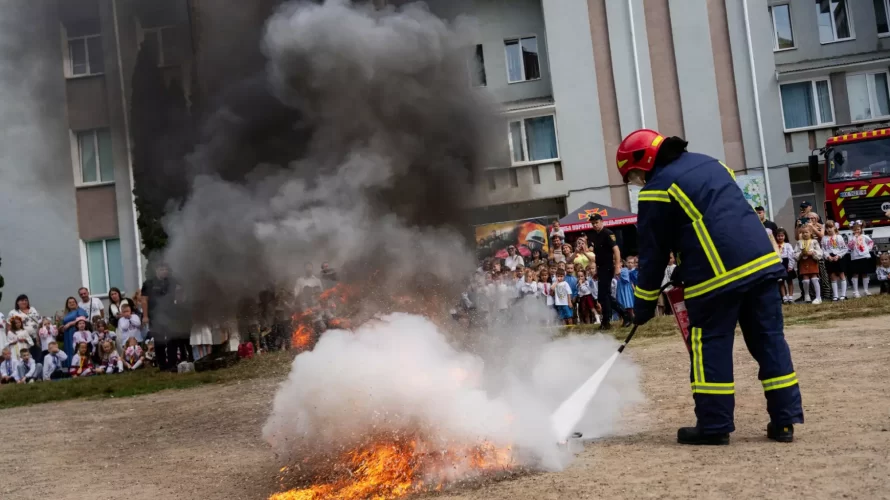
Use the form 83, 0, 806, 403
0, 352, 294, 409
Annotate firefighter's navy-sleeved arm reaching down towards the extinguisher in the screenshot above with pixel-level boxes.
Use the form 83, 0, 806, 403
634, 189, 676, 325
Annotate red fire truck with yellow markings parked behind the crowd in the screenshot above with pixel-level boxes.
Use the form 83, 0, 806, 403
809, 123, 890, 252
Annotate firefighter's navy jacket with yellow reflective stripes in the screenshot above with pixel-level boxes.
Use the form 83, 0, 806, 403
634, 152, 784, 316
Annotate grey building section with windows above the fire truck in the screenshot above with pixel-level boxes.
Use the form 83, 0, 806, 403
768, 0, 890, 229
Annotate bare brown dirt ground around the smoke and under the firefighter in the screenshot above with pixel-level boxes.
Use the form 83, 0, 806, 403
0, 317, 890, 500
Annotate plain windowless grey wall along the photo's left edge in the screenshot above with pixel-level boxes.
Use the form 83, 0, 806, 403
0, 0, 81, 315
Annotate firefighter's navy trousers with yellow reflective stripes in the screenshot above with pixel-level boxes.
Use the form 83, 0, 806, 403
686, 279, 803, 434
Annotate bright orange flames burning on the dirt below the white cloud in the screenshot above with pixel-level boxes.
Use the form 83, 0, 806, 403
270, 440, 513, 500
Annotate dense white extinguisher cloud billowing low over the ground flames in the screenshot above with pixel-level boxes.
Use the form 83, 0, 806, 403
263, 305, 642, 477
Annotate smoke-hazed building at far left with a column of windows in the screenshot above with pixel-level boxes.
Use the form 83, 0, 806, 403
0, 0, 202, 314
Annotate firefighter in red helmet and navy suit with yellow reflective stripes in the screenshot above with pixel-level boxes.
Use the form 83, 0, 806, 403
617, 129, 803, 445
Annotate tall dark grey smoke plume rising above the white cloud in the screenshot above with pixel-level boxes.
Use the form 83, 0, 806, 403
165, 0, 496, 319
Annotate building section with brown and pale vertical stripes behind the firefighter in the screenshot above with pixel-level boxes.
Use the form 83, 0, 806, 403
402, 0, 793, 228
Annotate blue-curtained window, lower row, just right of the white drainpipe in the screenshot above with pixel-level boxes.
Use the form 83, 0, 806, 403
779, 78, 834, 131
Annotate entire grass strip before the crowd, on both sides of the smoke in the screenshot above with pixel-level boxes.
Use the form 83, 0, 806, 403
0, 296, 890, 409
